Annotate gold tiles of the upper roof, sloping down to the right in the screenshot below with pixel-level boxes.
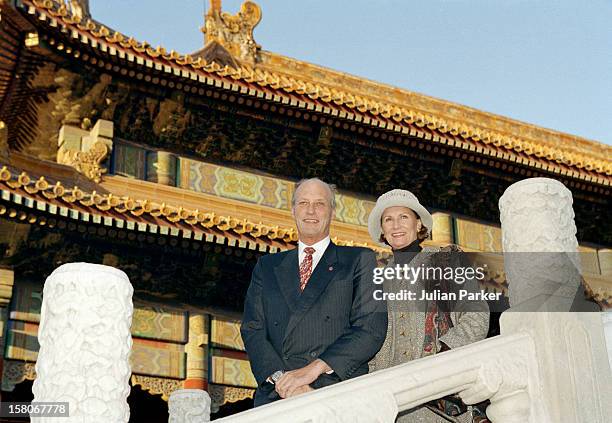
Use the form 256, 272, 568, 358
17, 0, 612, 178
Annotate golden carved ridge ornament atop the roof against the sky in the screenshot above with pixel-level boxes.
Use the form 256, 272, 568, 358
201, 0, 261, 63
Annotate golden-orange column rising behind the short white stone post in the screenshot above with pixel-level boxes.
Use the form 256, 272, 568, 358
184, 312, 208, 389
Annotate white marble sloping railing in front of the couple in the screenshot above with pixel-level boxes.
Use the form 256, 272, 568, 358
217, 312, 612, 423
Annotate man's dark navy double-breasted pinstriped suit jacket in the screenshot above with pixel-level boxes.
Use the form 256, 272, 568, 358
241, 243, 387, 406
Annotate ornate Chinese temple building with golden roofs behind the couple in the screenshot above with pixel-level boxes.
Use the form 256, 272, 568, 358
0, 0, 612, 422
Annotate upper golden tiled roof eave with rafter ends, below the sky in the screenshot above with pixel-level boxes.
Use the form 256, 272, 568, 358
9, 0, 612, 186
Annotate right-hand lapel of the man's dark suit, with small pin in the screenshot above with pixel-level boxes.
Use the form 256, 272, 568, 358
285, 242, 338, 339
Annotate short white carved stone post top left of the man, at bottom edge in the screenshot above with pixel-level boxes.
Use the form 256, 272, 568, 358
168, 389, 210, 423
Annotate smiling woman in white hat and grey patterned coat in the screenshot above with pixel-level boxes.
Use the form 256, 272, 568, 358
368, 189, 489, 422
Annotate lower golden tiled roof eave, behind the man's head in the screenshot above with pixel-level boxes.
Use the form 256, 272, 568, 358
0, 153, 386, 253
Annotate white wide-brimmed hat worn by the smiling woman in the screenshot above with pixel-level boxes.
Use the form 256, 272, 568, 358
368, 189, 433, 247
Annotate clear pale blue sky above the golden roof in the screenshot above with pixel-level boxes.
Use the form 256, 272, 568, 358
90, 0, 612, 144
